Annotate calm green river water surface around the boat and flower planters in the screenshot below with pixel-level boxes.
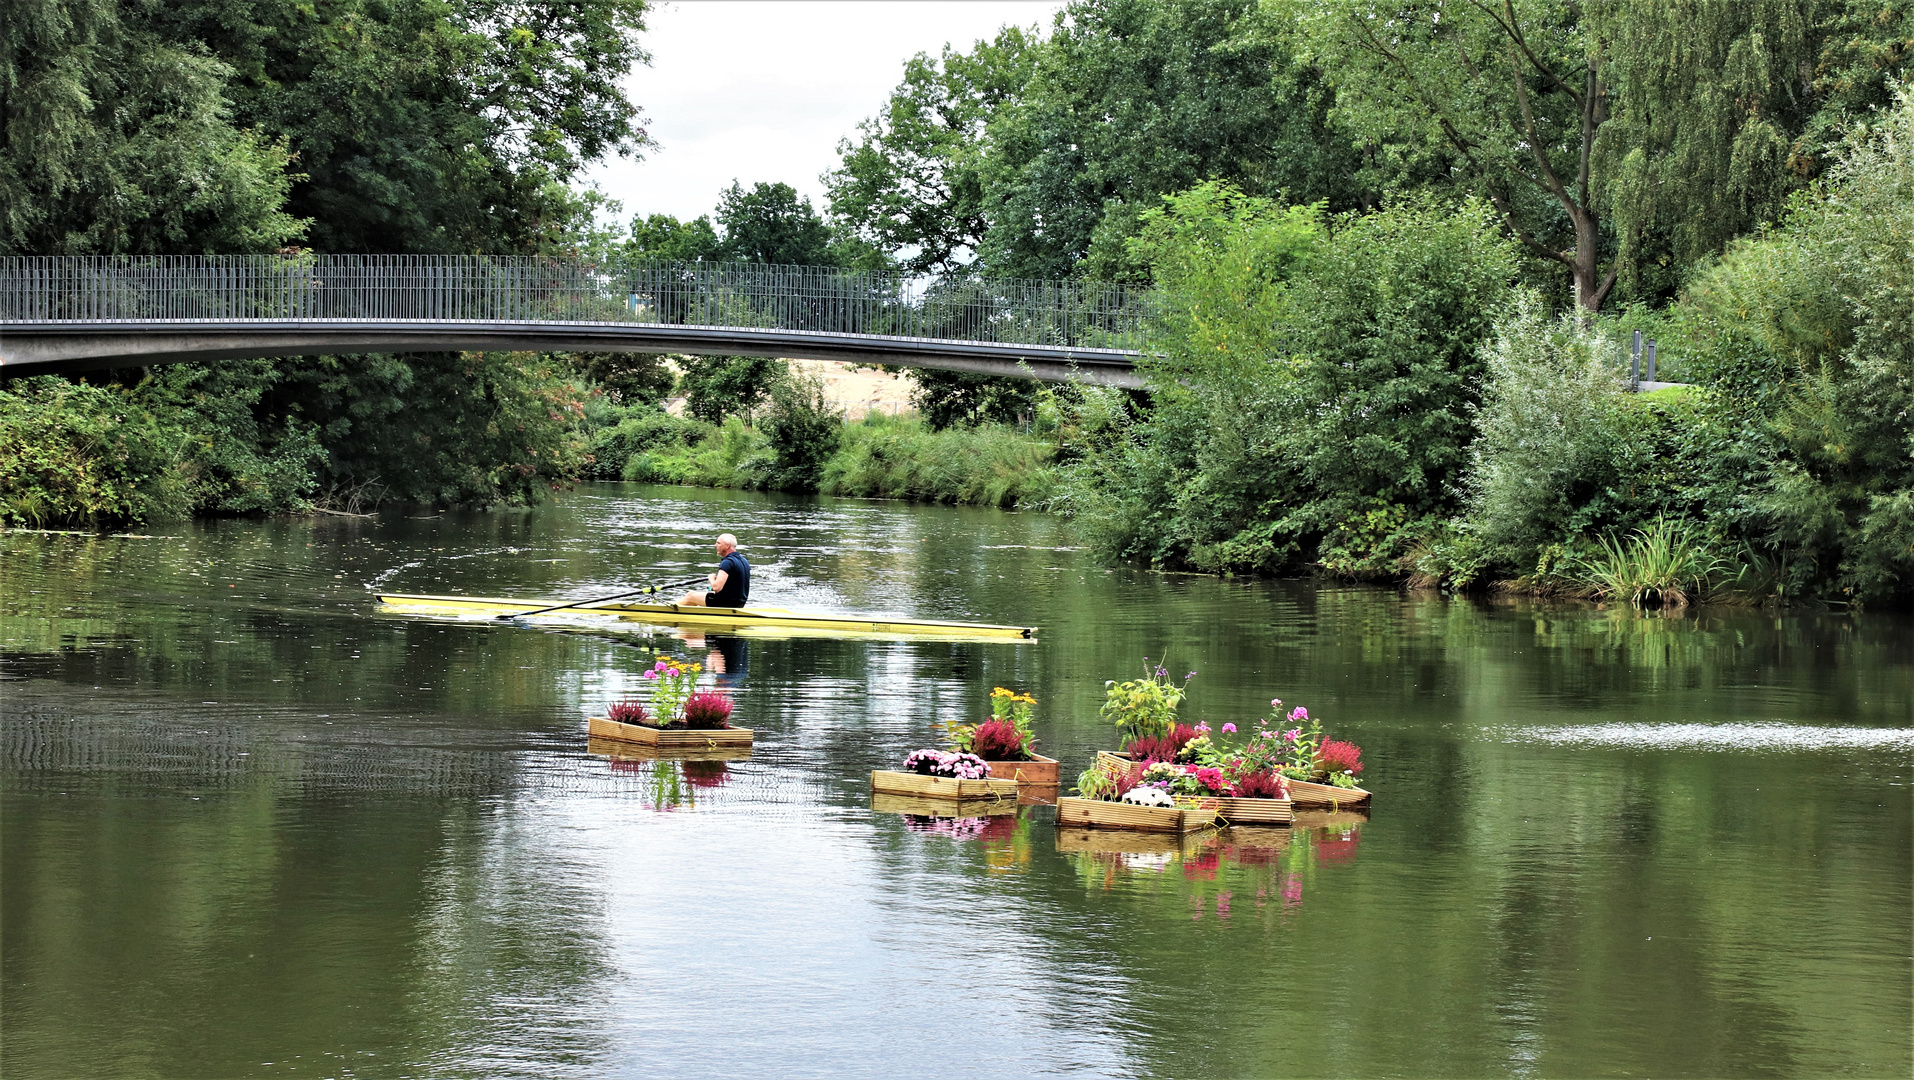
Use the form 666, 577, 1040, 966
0, 484, 1914, 1080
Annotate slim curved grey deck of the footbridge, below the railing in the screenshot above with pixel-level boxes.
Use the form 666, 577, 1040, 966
0, 320, 1143, 387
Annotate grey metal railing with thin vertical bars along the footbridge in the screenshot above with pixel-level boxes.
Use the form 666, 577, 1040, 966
0, 255, 1150, 349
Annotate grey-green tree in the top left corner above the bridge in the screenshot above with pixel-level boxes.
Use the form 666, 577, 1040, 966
0, 0, 310, 255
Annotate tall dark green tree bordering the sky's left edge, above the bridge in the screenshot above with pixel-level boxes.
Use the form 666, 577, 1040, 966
153, 0, 649, 253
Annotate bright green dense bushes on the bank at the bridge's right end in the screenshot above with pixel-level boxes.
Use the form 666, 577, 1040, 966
1060, 186, 1514, 574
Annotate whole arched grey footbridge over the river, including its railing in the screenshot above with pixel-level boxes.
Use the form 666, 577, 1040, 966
0, 255, 1148, 387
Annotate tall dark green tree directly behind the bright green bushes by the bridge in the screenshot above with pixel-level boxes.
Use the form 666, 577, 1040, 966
982, 0, 1374, 280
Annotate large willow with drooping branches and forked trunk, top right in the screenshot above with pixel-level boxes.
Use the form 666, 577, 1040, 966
1282, 0, 1836, 312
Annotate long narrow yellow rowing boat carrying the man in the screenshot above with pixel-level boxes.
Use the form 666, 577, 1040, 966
379, 592, 1037, 641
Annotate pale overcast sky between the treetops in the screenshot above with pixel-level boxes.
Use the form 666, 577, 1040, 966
590, 0, 1062, 229
